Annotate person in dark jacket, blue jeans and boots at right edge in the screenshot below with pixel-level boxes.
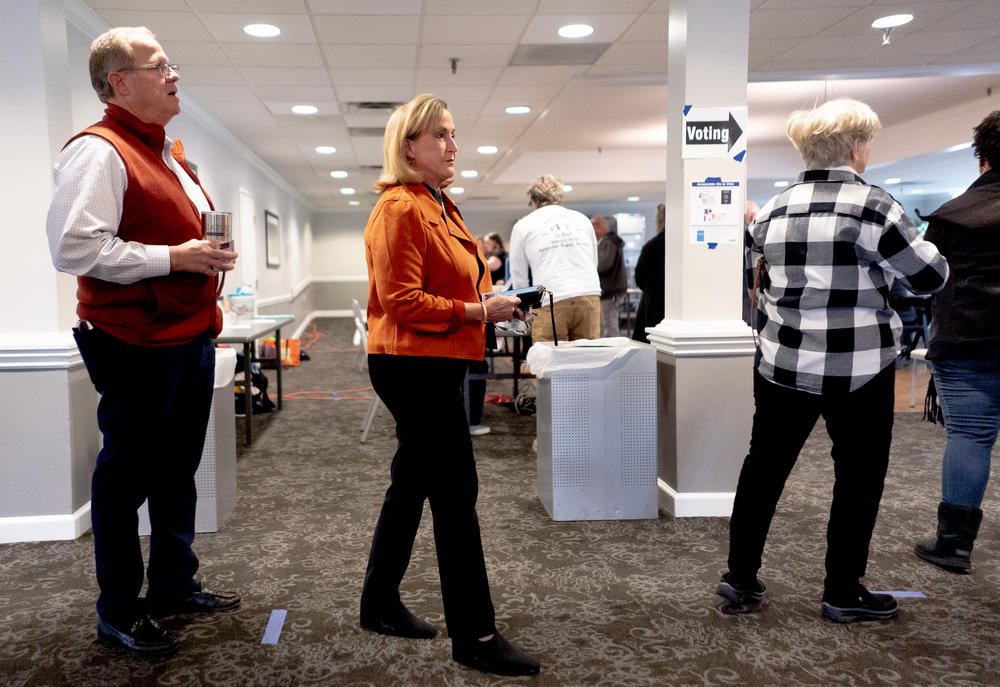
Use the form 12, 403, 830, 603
916, 110, 1000, 573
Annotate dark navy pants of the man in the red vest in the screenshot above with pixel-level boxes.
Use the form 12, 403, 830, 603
74, 328, 215, 627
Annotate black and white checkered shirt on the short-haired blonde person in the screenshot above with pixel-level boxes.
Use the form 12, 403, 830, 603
746, 168, 948, 394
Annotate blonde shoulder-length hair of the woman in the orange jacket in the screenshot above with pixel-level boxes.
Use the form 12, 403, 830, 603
375, 93, 455, 193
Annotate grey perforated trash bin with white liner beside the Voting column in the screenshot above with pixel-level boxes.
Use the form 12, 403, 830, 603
527, 337, 658, 520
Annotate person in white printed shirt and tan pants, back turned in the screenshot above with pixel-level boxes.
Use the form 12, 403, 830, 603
508, 174, 601, 341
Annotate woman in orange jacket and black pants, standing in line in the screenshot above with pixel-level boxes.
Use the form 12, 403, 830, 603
361, 93, 539, 675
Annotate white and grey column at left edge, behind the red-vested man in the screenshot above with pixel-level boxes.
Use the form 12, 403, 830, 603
0, 0, 98, 542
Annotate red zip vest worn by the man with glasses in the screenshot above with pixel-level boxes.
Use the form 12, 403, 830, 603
70, 105, 222, 346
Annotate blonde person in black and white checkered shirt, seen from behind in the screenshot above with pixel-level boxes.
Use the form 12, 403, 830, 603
716, 99, 948, 622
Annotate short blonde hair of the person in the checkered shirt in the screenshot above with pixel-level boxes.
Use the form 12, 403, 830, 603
785, 98, 882, 169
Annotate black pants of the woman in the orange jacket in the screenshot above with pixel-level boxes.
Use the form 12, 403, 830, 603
361, 355, 496, 639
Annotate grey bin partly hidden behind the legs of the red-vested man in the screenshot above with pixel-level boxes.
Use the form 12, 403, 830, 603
139, 348, 236, 535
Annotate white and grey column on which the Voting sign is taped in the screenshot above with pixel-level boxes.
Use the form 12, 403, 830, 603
649, 0, 754, 517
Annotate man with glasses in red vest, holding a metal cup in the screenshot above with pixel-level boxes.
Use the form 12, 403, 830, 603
46, 27, 240, 655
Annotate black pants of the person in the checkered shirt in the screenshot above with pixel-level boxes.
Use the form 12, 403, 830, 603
729, 366, 895, 594
